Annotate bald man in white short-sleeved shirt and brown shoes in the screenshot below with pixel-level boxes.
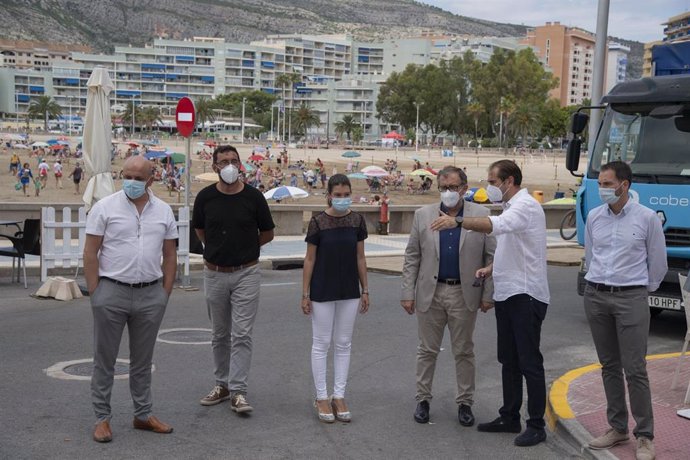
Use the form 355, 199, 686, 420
84, 156, 177, 442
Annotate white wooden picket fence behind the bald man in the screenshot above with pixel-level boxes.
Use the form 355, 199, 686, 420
41, 207, 190, 284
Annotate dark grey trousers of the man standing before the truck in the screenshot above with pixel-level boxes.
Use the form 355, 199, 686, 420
584, 286, 654, 439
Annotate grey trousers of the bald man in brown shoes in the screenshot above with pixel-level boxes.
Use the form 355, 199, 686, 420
91, 280, 168, 422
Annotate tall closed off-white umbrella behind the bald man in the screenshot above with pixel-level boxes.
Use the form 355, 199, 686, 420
82, 67, 115, 211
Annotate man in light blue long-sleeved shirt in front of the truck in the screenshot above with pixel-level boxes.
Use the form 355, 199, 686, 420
584, 161, 668, 460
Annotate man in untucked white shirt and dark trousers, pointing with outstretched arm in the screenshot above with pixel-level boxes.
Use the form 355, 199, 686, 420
446, 160, 549, 446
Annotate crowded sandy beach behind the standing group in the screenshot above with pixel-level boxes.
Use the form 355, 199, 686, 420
0, 133, 577, 205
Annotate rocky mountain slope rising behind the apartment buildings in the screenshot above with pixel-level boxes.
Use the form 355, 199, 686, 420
0, 0, 641, 75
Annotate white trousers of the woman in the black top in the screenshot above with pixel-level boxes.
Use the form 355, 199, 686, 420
311, 299, 359, 399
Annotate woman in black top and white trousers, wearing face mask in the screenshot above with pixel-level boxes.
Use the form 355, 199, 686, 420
302, 174, 369, 423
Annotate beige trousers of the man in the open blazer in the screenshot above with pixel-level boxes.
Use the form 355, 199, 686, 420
416, 283, 477, 406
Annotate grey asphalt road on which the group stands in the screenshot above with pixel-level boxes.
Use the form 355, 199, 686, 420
0, 267, 685, 459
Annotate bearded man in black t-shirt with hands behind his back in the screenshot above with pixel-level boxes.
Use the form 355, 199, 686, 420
192, 145, 275, 413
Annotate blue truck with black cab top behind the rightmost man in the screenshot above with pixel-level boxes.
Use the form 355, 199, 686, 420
566, 73, 690, 315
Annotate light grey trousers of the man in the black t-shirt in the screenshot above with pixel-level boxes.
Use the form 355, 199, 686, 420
204, 265, 261, 394
